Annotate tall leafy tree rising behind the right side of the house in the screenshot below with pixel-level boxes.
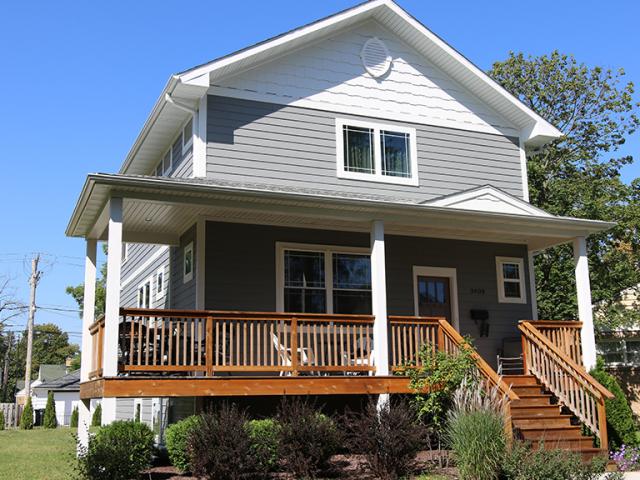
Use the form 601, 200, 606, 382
489, 51, 640, 327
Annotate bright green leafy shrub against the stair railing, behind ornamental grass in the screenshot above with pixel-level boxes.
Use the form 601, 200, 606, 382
398, 339, 476, 432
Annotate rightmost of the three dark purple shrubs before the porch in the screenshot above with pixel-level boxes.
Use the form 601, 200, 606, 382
344, 399, 424, 480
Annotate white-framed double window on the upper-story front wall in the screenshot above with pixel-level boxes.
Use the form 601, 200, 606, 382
336, 119, 418, 185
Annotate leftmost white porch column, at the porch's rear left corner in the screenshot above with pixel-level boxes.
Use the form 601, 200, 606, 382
78, 238, 98, 448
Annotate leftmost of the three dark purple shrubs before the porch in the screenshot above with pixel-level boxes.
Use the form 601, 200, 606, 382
187, 403, 256, 480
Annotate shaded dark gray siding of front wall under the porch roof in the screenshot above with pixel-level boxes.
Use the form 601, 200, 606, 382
205, 222, 531, 364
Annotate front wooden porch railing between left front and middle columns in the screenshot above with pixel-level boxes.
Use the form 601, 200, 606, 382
119, 309, 375, 375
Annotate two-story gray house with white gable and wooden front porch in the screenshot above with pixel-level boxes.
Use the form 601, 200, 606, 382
67, 0, 612, 453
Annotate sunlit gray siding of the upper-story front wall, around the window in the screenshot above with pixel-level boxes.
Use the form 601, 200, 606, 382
207, 96, 523, 201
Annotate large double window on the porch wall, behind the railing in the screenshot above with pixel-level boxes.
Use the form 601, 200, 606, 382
279, 245, 371, 314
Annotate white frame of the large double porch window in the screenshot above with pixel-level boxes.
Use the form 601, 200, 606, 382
276, 242, 373, 315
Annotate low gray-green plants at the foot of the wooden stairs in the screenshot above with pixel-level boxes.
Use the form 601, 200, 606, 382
503, 442, 610, 480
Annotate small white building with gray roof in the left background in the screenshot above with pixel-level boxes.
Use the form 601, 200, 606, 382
31, 370, 80, 426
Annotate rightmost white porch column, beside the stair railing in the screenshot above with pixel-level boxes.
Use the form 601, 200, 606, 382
573, 237, 596, 371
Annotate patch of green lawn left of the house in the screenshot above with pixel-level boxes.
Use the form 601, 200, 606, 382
0, 428, 76, 480
